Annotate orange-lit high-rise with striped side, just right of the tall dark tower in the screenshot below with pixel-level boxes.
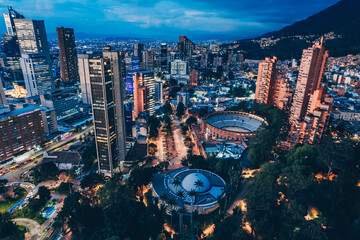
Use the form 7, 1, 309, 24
133, 72, 155, 120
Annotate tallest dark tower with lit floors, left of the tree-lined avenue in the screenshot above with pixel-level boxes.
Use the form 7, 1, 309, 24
89, 52, 126, 176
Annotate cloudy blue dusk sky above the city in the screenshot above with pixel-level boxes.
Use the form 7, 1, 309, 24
0, 0, 339, 40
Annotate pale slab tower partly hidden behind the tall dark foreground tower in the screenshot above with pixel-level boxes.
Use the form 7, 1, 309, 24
77, 53, 100, 105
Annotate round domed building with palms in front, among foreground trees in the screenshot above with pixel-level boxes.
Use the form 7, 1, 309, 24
152, 167, 226, 214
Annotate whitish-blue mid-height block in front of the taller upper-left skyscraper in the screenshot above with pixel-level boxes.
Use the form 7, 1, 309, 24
20, 54, 54, 97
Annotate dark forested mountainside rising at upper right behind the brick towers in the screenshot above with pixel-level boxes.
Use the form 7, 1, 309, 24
224, 0, 360, 59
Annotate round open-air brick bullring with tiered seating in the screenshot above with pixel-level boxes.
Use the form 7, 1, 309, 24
201, 111, 268, 141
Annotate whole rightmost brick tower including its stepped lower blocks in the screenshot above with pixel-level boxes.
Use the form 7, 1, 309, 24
289, 39, 333, 145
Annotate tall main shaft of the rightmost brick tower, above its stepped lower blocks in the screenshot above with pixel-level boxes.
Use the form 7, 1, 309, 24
290, 40, 328, 124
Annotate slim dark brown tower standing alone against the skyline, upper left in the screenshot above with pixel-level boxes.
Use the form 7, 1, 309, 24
56, 27, 78, 82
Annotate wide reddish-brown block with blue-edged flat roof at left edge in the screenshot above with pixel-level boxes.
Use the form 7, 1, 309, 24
0, 106, 45, 161
